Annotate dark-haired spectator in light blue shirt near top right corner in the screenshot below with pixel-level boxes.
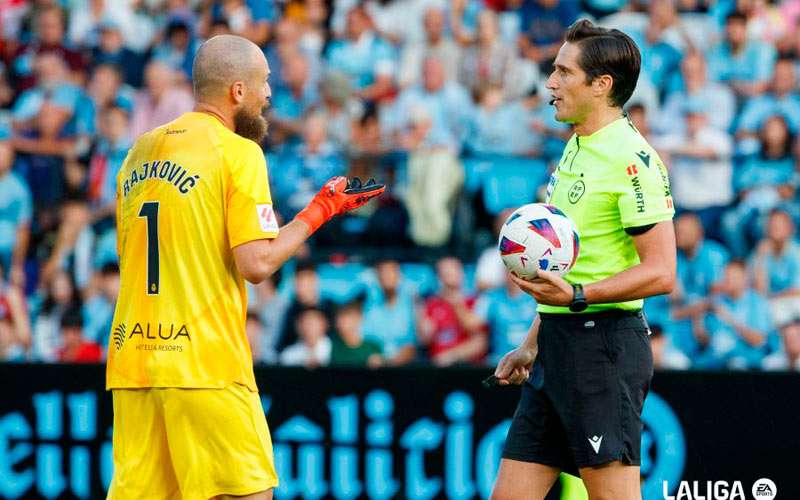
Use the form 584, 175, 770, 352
708, 12, 777, 96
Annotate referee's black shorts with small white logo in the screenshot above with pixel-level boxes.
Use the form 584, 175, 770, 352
503, 310, 653, 475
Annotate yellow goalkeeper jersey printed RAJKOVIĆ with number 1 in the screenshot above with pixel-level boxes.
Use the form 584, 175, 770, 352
106, 112, 278, 390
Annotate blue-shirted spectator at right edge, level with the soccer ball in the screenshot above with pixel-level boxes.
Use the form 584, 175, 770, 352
753, 210, 800, 328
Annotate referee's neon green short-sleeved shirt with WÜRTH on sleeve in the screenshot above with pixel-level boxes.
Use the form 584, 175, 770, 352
538, 117, 675, 314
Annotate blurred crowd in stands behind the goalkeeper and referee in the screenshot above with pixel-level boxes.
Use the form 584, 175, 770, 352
0, 0, 800, 369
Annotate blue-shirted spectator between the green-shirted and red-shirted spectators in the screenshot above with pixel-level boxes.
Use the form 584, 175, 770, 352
363, 260, 417, 366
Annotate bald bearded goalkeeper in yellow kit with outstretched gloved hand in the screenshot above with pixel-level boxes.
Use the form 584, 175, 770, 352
106, 35, 384, 499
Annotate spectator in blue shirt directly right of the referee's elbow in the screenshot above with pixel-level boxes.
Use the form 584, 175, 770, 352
668, 212, 730, 364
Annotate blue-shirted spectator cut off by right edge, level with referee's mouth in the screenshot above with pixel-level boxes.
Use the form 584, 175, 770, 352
736, 59, 800, 147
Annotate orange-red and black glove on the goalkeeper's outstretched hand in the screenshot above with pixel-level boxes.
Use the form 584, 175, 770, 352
295, 177, 386, 234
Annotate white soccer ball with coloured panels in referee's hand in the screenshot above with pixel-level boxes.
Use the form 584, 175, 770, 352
498, 203, 580, 279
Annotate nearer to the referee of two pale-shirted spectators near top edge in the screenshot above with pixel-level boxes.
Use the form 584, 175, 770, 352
459, 10, 521, 96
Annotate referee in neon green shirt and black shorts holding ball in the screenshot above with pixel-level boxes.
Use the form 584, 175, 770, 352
492, 20, 675, 500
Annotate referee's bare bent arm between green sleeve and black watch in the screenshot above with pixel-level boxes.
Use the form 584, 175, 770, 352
570, 220, 676, 304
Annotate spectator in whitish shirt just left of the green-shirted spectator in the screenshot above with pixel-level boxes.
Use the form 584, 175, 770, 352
281, 307, 331, 368
